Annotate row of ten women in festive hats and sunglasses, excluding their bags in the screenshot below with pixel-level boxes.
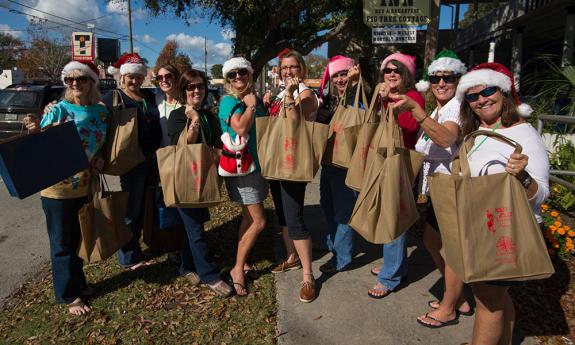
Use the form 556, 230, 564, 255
26, 45, 549, 344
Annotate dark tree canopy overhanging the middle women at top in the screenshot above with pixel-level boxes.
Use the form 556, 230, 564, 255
144, 0, 362, 77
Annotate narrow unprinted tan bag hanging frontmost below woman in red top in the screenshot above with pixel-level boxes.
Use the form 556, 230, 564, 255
349, 114, 419, 244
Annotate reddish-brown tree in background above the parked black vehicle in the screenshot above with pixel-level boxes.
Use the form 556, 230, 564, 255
17, 38, 71, 83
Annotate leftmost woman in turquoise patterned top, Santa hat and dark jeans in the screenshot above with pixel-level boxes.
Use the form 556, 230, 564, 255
24, 61, 108, 315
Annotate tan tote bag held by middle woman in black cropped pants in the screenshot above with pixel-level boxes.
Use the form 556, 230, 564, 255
256, 101, 329, 182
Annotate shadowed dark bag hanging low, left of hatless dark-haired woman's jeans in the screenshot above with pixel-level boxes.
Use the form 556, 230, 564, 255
142, 186, 186, 254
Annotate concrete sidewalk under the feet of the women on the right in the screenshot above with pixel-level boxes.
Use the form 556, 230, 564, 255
276, 174, 538, 345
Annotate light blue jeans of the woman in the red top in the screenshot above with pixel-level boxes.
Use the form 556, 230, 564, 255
377, 233, 407, 291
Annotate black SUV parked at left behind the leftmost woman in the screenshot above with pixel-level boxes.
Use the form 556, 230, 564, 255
0, 84, 64, 139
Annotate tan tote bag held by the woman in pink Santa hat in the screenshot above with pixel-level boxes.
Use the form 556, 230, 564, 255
322, 76, 368, 168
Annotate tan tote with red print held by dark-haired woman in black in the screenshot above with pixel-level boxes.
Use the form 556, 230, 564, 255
156, 120, 223, 208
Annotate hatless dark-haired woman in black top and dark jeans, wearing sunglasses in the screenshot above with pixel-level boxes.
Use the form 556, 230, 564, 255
168, 69, 233, 297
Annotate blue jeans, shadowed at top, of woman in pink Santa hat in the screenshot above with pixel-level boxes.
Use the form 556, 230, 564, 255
320, 166, 357, 271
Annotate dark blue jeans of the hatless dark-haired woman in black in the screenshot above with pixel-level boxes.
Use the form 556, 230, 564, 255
177, 208, 221, 284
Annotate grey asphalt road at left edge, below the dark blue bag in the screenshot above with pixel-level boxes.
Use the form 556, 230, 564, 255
0, 184, 50, 307
